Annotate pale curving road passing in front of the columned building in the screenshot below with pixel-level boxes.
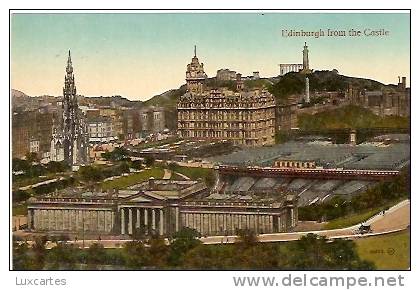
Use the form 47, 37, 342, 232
18, 200, 410, 248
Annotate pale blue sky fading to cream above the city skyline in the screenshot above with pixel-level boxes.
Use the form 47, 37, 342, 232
11, 13, 410, 100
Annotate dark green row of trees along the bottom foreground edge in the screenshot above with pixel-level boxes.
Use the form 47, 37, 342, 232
13, 228, 375, 270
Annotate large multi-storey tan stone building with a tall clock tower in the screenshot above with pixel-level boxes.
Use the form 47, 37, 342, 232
177, 49, 276, 146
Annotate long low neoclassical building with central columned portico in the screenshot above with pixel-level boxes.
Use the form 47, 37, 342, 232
28, 179, 297, 236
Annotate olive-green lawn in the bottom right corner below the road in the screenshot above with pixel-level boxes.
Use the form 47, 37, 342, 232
356, 230, 410, 270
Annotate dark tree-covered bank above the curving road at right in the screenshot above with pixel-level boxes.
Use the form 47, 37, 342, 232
299, 170, 410, 221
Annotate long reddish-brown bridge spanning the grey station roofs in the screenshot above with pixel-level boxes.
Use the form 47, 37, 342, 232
215, 165, 400, 181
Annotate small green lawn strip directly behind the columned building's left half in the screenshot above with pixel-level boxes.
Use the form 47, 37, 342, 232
101, 167, 163, 190
